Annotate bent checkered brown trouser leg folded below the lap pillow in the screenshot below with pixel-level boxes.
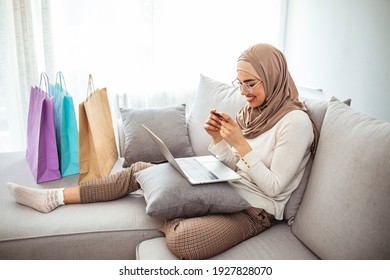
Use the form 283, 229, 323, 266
161, 208, 274, 259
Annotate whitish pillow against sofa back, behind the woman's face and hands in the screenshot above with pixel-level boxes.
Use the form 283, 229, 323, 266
187, 75, 246, 156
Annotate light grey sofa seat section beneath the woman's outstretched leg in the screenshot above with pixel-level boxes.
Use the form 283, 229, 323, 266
0, 153, 163, 259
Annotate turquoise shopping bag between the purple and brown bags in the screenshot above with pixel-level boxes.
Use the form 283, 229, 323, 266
49, 72, 80, 177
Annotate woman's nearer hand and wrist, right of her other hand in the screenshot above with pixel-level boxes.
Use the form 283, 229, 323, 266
219, 113, 252, 157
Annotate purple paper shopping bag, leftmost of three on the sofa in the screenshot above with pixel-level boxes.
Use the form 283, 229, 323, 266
26, 73, 61, 183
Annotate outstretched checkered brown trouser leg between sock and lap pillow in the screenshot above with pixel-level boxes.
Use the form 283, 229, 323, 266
80, 162, 152, 203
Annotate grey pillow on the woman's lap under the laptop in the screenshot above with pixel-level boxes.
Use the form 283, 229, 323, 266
135, 163, 250, 219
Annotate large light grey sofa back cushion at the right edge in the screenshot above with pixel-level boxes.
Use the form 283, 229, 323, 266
292, 100, 390, 259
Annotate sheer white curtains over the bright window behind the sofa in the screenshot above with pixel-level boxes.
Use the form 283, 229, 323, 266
0, 0, 280, 152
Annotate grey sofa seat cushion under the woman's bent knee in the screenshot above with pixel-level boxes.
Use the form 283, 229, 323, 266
137, 223, 318, 260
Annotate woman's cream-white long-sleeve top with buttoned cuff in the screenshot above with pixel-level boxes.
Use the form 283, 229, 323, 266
209, 110, 314, 220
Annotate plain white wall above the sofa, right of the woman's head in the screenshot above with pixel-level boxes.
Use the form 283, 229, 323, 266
284, 0, 390, 121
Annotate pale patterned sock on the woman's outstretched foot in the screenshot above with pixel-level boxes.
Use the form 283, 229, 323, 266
7, 182, 64, 213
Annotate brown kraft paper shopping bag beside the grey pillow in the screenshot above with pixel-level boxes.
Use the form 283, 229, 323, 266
79, 75, 118, 183
